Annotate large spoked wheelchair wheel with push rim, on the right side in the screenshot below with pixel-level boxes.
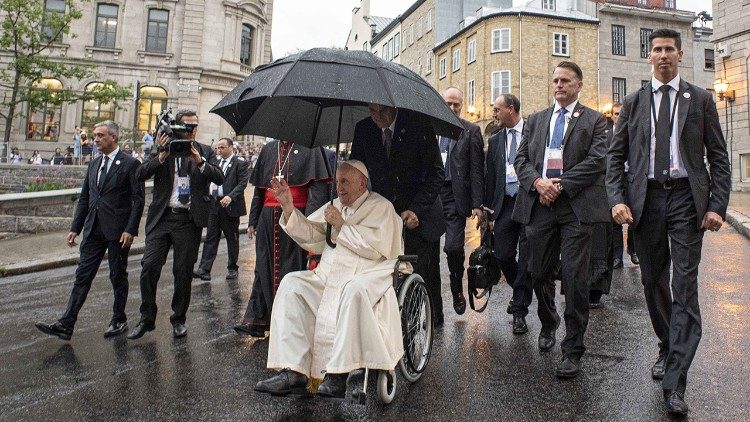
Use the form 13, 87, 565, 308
398, 274, 432, 382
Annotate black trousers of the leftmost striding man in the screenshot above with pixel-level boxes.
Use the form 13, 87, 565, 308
60, 219, 130, 330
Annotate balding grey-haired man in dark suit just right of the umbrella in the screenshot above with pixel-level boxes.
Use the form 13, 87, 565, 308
438, 87, 484, 320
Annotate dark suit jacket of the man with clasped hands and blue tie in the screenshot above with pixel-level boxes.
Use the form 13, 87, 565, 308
513, 103, 611, 224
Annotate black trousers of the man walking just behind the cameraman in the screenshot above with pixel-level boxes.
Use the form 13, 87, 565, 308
198, 201, 240, 273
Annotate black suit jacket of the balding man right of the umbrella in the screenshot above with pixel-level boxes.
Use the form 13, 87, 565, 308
446, 119, 484, 217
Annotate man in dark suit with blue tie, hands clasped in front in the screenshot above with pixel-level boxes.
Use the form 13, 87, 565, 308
513, 61, 610, 378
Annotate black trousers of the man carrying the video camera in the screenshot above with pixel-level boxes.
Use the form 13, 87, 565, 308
141, 210, 203, 325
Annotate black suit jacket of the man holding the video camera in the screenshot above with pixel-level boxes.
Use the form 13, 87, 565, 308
137, 142, 224, 234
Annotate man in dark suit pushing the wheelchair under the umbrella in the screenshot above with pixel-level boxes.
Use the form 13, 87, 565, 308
349, 104, 445, 325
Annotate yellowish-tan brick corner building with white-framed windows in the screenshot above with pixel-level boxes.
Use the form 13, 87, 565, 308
434, 7, 599, 133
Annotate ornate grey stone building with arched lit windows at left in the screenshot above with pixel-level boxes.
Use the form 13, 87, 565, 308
0, 0, 273, 157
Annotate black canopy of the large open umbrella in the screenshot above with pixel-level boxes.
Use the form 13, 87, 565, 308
211, 48, 463, 147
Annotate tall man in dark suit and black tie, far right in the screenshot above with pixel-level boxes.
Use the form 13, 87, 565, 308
607, 29, 731, 415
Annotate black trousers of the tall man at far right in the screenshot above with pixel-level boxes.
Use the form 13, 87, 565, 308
634, 184, 703, 393
